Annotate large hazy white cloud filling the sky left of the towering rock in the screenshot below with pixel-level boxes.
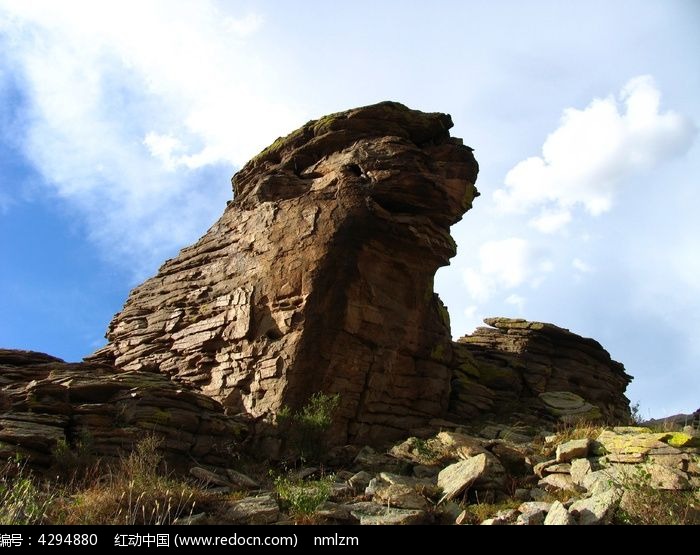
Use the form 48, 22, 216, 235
0, 0, 308, 273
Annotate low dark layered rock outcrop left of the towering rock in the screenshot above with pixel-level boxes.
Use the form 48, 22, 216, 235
0, 349, 246, 468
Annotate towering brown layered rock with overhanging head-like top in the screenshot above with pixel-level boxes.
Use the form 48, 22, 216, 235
91, 102, 478, 441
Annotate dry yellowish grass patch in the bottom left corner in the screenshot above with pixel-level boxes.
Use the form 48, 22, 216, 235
0, 436, 234, 525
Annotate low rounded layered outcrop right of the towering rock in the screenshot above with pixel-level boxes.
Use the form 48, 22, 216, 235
451, 318, 632, 422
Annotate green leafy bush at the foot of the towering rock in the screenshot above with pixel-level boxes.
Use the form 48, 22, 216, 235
277, 392, 340, 461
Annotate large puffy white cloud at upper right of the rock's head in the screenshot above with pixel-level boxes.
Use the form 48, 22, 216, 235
494, 75, 697, 233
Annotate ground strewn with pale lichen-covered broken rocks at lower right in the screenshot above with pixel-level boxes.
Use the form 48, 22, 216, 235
178, 425, 700, 525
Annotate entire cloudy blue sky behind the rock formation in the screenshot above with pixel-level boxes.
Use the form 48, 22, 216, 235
0, 0, 700, 416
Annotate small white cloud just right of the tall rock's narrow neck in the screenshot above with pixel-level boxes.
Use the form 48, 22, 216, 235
463, 237, 554, 304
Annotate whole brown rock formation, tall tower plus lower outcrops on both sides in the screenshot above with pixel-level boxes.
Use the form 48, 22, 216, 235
0, 102, 629, 466
